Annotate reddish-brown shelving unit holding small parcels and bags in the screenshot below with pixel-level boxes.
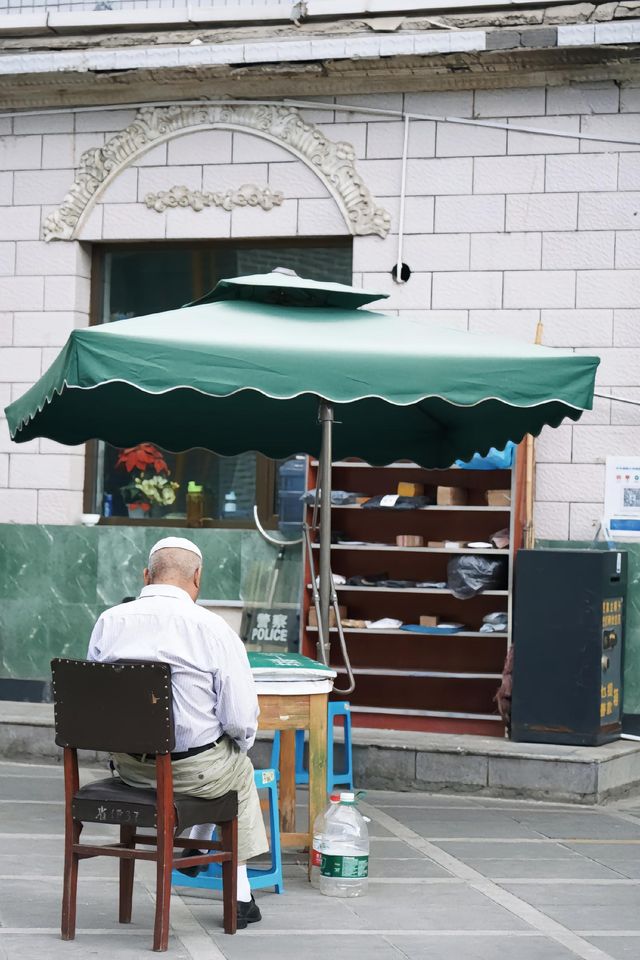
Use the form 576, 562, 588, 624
301, 460, 515, 736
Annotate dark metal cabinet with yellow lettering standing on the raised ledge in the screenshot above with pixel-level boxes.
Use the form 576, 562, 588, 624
511, 550, 627, 746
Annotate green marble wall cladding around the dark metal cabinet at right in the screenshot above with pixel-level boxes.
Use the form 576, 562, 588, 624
536, 540, 640, 714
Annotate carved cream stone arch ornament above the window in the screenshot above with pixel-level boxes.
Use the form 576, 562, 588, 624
42, 103, 391, 240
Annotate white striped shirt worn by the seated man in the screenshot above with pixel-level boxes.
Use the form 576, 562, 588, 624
87, 584, 259, 752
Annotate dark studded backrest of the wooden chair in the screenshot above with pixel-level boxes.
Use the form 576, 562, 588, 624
51, 658, 175, 754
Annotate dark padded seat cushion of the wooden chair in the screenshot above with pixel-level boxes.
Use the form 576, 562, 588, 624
72, 777, 238, 833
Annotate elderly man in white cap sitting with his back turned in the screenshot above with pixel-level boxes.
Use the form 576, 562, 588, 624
87, 537, 268, 928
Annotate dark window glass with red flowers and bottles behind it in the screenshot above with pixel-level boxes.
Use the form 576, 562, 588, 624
89, 239, 351, 532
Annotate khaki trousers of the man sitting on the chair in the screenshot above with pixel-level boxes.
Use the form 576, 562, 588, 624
113, 737, 269, 862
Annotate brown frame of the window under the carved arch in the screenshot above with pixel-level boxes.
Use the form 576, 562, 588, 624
83, 236, 352, 530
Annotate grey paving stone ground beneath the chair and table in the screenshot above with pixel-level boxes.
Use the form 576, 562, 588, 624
0, 762, 640, 960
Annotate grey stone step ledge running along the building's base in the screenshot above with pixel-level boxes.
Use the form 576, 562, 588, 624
0, 701, 640, 804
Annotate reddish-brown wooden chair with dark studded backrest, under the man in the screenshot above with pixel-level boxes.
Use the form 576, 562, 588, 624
51, 659, 238, 950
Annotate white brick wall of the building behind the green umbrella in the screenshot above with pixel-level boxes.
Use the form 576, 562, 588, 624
0, 81, 640, 538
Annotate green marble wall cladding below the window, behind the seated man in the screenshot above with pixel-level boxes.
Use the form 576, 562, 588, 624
0, 524, 301, 680
